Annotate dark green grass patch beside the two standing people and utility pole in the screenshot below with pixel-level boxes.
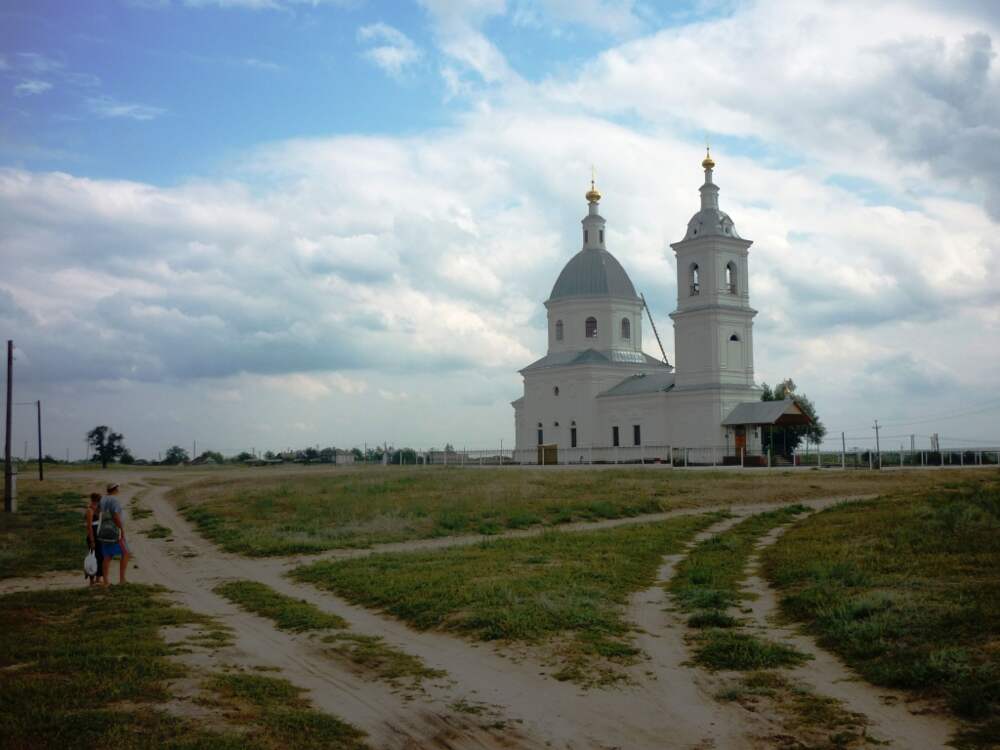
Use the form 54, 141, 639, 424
0, 480, 87, 581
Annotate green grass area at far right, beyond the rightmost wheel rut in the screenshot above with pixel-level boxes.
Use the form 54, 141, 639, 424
764, 478, 1000, 747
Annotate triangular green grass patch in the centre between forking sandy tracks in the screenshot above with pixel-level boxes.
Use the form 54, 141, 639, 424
292, 514, 719, 683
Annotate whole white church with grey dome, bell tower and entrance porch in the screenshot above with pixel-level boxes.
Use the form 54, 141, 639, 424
512, 154, 803, 463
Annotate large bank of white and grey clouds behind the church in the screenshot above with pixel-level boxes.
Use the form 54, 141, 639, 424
7, 0, 1000, 456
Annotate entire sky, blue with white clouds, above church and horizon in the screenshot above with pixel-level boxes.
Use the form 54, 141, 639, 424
0, 0, 1000, 456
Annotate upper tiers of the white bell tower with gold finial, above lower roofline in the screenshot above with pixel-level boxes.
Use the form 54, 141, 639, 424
670, 150, 757, 391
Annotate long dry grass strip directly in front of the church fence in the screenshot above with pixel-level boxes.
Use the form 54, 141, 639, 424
172, 467, 984, 556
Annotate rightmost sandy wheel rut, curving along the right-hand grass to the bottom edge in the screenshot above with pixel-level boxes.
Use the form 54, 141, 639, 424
744, 525, 956, 750
